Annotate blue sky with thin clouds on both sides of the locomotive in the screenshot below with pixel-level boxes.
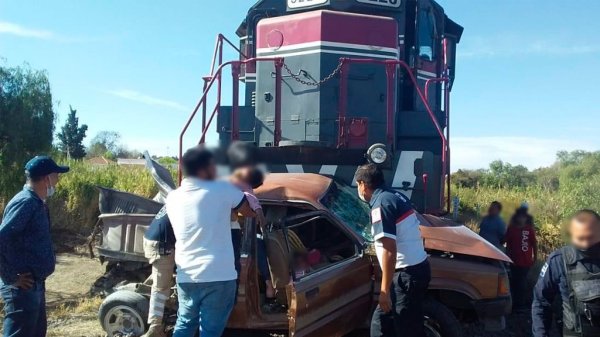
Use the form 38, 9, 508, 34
0, 0, 600, 170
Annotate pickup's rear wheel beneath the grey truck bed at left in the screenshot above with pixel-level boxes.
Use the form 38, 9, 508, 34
98, 290, 150, 337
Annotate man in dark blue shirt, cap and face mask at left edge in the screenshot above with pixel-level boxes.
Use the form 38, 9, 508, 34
0, 156, 69, 337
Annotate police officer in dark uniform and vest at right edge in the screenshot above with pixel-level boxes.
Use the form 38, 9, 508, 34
532, 210, 600, 337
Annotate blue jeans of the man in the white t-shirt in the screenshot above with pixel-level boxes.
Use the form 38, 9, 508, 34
173, 280, 237, 337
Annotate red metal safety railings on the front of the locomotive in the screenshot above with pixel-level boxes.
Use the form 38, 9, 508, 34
178, 34, 450, 211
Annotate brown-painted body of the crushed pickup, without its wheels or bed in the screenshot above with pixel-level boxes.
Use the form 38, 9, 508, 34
229, 174, 510, 336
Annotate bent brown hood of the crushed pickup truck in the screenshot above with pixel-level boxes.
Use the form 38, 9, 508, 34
419, 215, 512, 263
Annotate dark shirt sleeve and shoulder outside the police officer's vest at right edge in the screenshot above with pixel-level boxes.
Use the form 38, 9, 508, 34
532, 245, 600, 337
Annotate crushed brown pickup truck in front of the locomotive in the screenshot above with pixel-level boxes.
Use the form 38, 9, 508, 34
92, 160, 511, 337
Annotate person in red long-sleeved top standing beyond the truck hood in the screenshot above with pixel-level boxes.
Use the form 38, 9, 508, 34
506, 208, 537, 310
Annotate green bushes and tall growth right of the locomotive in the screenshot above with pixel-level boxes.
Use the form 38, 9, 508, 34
453, 151, 600, 257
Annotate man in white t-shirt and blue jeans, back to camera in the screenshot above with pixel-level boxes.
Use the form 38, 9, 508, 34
166, 147, 255, 337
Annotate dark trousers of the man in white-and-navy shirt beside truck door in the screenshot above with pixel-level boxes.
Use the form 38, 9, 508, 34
371, 260, 431, 337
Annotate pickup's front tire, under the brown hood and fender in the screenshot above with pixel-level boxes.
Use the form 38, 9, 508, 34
423, 299, 463, 337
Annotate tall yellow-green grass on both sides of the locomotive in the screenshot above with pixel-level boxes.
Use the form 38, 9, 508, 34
0, 154, 600, 249
